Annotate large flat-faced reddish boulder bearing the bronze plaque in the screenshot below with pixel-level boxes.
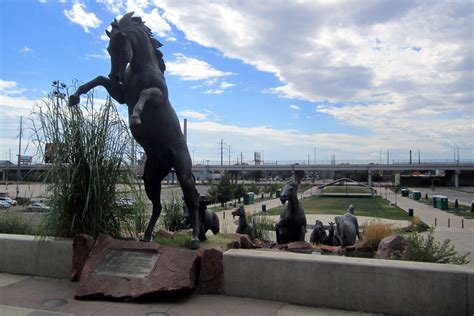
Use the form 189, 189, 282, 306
75, 235, 199, 300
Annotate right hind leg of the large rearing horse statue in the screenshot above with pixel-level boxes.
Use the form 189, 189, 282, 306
173, 143, 205, 249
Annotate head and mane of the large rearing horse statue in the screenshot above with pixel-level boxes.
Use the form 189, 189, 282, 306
105, 12, 166, 83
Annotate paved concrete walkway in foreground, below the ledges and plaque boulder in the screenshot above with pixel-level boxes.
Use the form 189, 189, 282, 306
0, 273, 378, 316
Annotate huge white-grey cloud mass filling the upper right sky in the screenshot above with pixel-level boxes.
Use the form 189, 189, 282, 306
155, 0, 474, 157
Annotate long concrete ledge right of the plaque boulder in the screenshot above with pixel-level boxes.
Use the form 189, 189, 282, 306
223, 249, 474, 315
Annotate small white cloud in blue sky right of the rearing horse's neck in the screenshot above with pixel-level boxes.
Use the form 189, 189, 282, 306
166, 53, 232, 81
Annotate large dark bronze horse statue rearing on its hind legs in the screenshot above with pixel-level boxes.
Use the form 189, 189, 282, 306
69, 12, 206, 249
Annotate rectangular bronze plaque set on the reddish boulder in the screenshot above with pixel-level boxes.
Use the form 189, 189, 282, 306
93, 249, 160, 279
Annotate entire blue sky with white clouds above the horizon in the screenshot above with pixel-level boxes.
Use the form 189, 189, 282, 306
0, 0, 474, 162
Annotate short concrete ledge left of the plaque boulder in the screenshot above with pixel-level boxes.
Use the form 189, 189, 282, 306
0, 234, 72, 278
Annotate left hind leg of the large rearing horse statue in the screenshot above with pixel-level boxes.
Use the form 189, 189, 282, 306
142, 157, 171, 241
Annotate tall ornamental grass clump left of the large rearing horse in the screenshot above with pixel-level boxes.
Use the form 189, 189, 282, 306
32, 90, 144, 237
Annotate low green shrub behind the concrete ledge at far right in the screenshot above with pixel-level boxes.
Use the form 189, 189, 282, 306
400, 232, 470, 264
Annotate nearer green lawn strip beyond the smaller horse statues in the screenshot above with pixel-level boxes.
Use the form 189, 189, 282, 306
259, 196, 411, 220
